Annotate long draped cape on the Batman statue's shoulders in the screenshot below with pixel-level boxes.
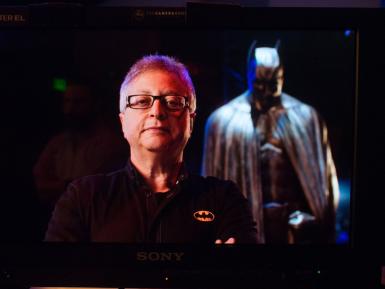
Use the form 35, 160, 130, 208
202, 91, 339, 243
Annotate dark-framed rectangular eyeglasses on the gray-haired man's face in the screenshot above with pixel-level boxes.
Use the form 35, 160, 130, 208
127, 94, 190, 111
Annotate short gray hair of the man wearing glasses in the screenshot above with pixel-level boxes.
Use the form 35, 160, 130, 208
119, 55, 196, 112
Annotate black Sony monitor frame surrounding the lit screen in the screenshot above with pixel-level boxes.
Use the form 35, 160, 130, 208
0, 5, 385, 288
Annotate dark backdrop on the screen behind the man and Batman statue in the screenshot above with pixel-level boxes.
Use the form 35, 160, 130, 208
0, 28, 356, 242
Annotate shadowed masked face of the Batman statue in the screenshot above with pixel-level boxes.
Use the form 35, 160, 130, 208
253, 66, 283, 100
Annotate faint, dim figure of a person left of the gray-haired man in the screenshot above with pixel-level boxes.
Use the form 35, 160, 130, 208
33, 80, 128, 209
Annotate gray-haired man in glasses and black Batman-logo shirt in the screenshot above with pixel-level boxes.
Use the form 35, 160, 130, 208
45, 55, 257, 243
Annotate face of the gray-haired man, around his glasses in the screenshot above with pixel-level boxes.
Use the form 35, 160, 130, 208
119, 70, 194, 154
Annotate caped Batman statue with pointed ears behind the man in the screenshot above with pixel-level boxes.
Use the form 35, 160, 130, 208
203, 44, 339, 244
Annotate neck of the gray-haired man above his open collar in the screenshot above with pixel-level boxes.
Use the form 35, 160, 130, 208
131, 153, 182, 192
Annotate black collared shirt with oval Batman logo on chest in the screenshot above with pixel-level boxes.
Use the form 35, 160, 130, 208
45, 163, 256, 244
